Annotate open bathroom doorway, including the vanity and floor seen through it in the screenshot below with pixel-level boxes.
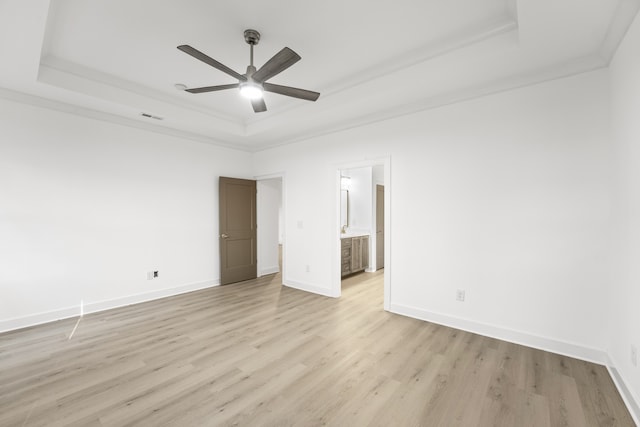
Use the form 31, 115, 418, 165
337, 161, 390, 310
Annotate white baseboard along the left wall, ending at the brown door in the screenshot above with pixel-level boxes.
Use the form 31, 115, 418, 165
0, 280, 220, 332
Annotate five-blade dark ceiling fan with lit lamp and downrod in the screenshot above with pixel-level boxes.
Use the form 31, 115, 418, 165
178, 30, 320, 113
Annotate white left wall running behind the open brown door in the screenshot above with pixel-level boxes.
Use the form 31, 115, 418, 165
0, 100, 253, 330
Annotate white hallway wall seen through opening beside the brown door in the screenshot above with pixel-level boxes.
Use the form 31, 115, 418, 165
257, 178, 282, 277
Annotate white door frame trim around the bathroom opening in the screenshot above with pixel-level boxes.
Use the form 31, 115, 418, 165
331, 156, 392, 311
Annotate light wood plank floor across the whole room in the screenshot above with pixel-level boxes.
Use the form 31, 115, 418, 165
0, 271, 634, 427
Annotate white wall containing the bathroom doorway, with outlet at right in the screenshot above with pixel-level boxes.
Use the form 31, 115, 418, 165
254, 71, 611, 360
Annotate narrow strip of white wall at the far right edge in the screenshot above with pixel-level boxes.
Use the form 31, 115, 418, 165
607, 10, 640, 420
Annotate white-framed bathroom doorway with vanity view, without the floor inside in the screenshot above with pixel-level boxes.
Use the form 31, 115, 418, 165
332, 158, 391, 310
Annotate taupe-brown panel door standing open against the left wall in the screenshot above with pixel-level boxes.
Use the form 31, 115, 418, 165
219, 177, 258, 285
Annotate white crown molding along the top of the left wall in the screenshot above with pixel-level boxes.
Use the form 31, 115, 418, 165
0, 88, 254, 152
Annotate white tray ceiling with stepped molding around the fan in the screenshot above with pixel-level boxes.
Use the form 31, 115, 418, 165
0, 0, 640, 151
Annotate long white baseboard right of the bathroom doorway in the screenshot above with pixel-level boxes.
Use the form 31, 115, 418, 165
389, 303, 608, 365
